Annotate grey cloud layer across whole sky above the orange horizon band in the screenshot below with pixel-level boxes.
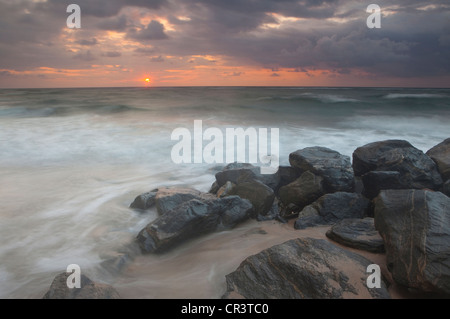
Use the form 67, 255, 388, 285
0, 0, 450, 82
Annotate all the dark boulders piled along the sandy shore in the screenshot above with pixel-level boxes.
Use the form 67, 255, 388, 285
46, 139, 450, 299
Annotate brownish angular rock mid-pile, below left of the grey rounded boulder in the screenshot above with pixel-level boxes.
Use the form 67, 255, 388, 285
278, 171, 325, 212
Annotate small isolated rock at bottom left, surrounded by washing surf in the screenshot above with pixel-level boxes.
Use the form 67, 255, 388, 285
43, 272, 120, 299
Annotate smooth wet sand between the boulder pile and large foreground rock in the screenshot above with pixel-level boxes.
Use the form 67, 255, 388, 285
113, 220, 413, 299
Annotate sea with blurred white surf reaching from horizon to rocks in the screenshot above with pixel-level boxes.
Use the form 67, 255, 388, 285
0, 87, 450, 298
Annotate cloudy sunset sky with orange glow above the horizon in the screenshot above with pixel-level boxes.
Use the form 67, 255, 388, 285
0, 0, 450, 88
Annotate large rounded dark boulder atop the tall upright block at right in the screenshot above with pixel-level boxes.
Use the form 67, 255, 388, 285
353, 140, 442, 190
